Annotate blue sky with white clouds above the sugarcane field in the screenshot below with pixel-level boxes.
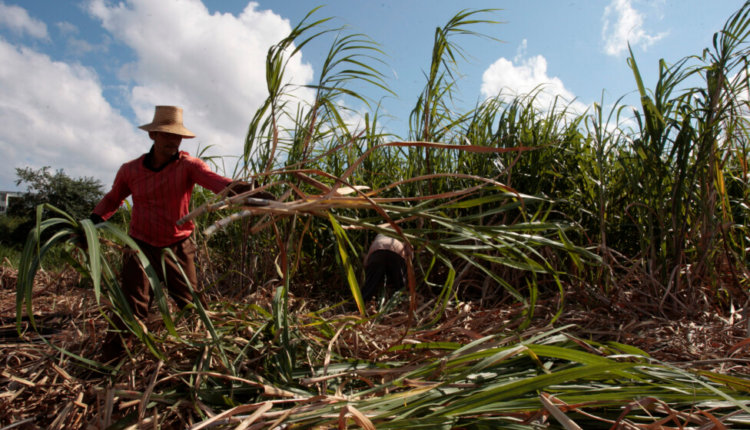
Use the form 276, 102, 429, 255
0, 0, 744, 190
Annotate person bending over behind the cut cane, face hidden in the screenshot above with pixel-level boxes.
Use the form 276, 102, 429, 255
362, 234, 411, 302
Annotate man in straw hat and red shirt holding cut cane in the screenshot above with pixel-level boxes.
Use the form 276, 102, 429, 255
91, 106, 274, 361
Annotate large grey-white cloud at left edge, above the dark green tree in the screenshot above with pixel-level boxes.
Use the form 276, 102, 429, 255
0, 39, 142, 189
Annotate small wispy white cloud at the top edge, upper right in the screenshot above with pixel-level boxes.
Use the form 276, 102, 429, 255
602, 0, 668, 56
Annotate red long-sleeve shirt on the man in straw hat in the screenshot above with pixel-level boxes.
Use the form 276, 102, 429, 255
94, 151, 232, 247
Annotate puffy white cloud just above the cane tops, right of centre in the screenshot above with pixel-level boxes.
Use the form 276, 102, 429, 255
481, 40, 586, 113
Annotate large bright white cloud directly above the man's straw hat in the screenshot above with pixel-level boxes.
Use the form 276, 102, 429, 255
88, 0, 313, 166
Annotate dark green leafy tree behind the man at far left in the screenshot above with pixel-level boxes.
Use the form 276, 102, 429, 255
8, 166, 104, 219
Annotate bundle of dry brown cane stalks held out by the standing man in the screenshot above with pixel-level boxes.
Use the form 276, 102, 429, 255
179, 142, 532, 315
